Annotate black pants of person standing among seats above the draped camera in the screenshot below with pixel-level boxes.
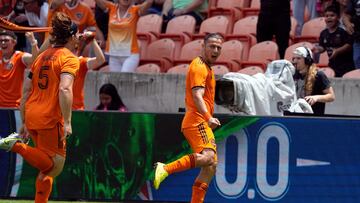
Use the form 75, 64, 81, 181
256, 14, 291, 58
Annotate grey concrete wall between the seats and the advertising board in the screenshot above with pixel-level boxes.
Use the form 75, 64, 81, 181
85, 72, 360, 115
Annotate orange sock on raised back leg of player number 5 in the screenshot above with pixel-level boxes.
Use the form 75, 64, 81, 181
11, 142, 53, 173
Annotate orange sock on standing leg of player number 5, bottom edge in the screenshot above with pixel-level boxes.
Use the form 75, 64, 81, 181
35, 176, 53, 203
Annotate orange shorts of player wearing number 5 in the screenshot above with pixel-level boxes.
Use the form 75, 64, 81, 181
29, 123, 66, 157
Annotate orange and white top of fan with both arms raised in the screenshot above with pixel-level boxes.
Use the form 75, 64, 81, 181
106, 1, 140, 56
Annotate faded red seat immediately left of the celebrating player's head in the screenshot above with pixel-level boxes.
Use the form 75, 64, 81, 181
174, 39, 203, 65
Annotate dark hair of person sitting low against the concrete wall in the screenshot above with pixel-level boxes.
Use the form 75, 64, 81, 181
96, 83, 126, 110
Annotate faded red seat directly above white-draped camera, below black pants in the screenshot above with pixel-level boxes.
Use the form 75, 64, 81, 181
241, 41, 280, 71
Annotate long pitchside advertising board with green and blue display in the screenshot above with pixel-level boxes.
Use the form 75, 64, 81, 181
0, 110, 360, 203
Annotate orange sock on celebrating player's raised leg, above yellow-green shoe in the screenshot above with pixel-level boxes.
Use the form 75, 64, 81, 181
164, 154, 195, 174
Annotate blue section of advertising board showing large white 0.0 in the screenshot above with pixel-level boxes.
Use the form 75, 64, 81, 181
151, 118, 360, 203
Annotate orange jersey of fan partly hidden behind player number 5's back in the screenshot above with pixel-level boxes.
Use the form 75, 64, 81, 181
72, 56, 89, 110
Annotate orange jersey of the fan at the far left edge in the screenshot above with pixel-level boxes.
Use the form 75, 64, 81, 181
0, 51, 26, 108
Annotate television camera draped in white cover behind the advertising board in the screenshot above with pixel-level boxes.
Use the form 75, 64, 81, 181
215, 60, 312, 116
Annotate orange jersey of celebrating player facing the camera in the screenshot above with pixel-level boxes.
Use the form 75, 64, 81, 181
181, 57, 215, 128
